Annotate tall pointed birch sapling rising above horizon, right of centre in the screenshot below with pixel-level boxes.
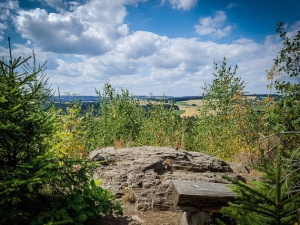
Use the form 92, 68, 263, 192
187, 58, 259, 160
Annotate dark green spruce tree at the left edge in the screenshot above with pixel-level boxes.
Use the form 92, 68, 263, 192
0, 37, 52, 171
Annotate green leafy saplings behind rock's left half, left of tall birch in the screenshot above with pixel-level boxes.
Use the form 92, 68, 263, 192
72, 83, 184, 149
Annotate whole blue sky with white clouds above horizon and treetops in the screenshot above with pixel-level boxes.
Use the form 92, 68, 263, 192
0, 0, 300, 96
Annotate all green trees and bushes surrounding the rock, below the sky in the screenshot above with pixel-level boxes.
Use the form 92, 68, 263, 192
0, 22, 300, 224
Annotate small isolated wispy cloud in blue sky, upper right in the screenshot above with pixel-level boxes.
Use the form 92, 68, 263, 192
194, 11, 232, 38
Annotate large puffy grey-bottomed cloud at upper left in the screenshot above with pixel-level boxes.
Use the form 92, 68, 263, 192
15, 0, 145, 55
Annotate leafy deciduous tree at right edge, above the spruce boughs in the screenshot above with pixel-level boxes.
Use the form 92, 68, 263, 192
266, 23, 300, 149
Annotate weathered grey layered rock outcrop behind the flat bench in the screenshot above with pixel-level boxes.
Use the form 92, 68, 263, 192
89, 146, 242, 211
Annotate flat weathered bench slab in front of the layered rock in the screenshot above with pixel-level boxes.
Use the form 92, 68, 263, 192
172, 180, 236, 213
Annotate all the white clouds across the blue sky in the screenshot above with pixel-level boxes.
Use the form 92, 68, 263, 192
0, 0, 300, 95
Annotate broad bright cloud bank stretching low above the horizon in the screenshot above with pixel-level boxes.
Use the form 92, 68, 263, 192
41, 27, 280, 95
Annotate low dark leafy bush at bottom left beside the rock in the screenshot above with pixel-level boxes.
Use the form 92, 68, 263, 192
31, 154, 122, 225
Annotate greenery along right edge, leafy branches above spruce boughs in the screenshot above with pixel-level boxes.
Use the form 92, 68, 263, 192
218, 23, 300, 225
